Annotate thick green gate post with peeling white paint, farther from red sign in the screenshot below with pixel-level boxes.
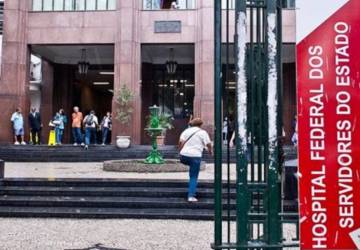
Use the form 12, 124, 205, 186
234, 0, 249, 245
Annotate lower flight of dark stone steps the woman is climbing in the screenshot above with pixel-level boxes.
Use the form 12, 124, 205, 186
0, 179, 297, 220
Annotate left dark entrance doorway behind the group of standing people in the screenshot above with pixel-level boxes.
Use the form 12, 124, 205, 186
31, 45, 114, 143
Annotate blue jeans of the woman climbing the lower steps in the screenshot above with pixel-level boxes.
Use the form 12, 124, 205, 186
180, 155, 201, 197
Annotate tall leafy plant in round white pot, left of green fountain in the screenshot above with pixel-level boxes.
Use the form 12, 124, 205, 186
115, 84, 134, 148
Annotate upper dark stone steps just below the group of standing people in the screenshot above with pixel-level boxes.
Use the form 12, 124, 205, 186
0, 145, 297, 163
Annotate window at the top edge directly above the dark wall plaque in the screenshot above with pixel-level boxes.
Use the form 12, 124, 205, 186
143, 0, 196, 10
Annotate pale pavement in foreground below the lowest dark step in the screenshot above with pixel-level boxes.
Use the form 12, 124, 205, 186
0, 219, 296, 250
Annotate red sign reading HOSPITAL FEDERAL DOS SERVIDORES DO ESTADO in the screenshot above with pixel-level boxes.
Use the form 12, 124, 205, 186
297, 0, 360, 249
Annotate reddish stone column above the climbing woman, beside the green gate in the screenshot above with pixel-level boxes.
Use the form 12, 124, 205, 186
194, 0, 214, 137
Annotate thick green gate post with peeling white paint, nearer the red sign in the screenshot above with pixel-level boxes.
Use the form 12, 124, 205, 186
267, 0, 282, 244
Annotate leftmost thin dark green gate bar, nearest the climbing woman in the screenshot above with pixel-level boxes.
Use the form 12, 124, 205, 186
214, 0, 222, 246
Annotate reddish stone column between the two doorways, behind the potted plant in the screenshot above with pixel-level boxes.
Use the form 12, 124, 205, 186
112, 0, 141, 144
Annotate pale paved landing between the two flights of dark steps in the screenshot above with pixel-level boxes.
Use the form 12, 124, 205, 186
5, 162, 235, 180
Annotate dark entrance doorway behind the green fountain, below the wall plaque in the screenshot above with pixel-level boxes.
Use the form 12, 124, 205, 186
141, 44, 195, 145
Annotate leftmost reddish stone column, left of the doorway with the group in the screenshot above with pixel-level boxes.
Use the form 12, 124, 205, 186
0, 0, 30, 143
